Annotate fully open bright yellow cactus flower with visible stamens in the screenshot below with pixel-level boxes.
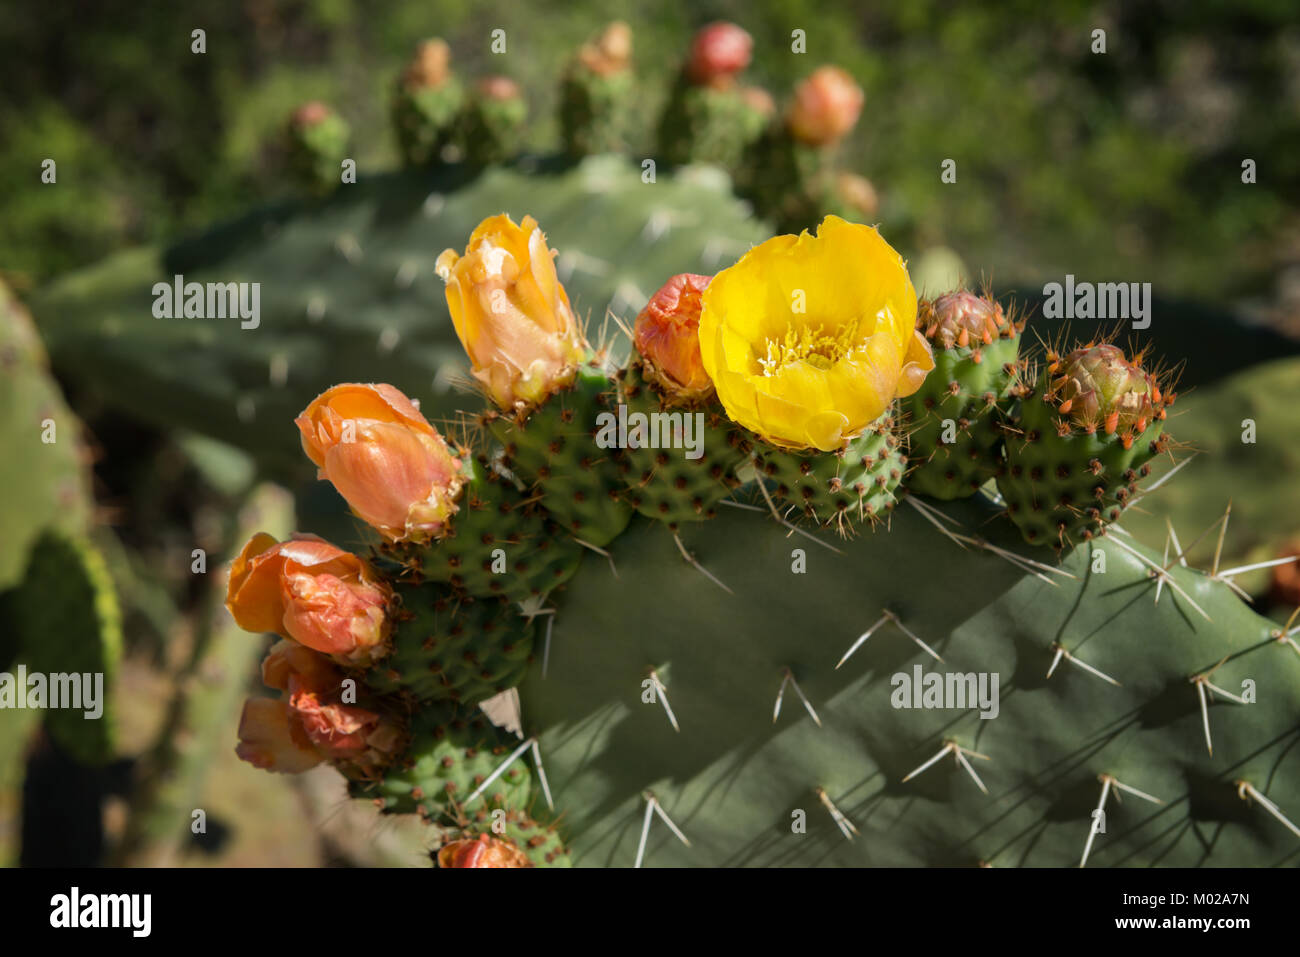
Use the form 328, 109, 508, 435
699, 216, 935, 451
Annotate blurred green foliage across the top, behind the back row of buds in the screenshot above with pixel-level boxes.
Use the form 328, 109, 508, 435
0, 0, 1300, 312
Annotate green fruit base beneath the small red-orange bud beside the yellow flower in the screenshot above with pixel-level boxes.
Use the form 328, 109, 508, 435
619, 361, 750, 524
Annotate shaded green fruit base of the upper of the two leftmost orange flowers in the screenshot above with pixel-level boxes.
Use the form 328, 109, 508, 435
365, 584, 534, 705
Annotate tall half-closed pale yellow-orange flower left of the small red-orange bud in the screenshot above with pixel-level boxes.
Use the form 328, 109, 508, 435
434, 215, 586, 410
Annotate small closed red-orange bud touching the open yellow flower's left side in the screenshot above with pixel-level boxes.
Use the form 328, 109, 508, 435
632, 273, 714, 402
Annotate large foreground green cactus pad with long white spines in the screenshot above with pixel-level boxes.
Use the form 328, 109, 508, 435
520, 499, 1300, 867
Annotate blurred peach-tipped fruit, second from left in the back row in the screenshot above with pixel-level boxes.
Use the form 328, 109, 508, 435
393, 39, 465, 166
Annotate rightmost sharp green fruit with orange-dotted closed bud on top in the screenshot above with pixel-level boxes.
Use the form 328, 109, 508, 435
997, 343, 1175, 551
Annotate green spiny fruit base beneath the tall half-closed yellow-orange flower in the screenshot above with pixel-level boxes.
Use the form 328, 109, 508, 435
486, 364, 632, 547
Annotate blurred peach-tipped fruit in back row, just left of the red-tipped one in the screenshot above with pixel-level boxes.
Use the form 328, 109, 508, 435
560, 22, 636, 157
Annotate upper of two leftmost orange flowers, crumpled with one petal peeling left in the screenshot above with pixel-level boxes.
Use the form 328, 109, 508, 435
226, 532, 391, 664
